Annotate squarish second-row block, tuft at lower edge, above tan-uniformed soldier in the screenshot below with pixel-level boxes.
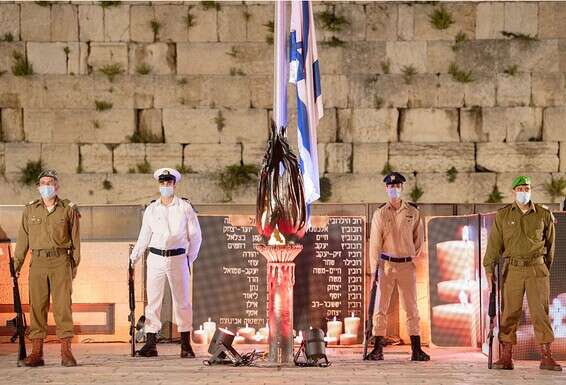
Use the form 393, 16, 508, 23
386, 41, 427, 73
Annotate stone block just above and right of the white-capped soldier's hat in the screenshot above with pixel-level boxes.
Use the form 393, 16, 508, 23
184, 143, 242, 173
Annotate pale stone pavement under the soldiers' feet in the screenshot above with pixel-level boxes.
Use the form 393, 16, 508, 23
0, 343, 566, 385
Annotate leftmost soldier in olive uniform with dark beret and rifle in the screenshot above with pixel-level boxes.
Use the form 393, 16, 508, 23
14, 170, 80, 366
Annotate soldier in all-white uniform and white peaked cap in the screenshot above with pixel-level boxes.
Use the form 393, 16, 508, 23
130, 168, 202, 358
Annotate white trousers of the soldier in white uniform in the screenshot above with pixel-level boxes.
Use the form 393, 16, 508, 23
145, 253, 193, 333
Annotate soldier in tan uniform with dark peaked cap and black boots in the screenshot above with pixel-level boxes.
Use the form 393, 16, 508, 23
366, 172, 430, 361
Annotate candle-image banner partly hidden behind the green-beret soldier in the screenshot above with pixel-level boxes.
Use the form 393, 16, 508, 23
480, 212, 566, 360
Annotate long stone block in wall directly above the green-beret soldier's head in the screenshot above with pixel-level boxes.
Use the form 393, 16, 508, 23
476, 142, 558, 173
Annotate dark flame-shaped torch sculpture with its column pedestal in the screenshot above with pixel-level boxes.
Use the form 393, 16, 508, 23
256, 124, 307, 365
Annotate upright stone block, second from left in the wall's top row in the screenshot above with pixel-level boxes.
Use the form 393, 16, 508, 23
20, 1, 51, 41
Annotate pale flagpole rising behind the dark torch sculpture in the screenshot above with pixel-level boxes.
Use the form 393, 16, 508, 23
273, 0, 289, 131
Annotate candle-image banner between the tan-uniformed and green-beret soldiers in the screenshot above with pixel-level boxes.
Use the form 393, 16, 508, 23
426, 215, 481, 347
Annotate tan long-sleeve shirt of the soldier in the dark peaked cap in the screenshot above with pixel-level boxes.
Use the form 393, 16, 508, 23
369, 201, 424, 274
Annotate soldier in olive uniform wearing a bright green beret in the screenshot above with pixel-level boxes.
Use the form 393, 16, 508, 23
483, 176, 562, 370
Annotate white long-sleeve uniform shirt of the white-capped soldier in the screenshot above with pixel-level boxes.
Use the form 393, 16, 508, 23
130, 197, 202, 264
